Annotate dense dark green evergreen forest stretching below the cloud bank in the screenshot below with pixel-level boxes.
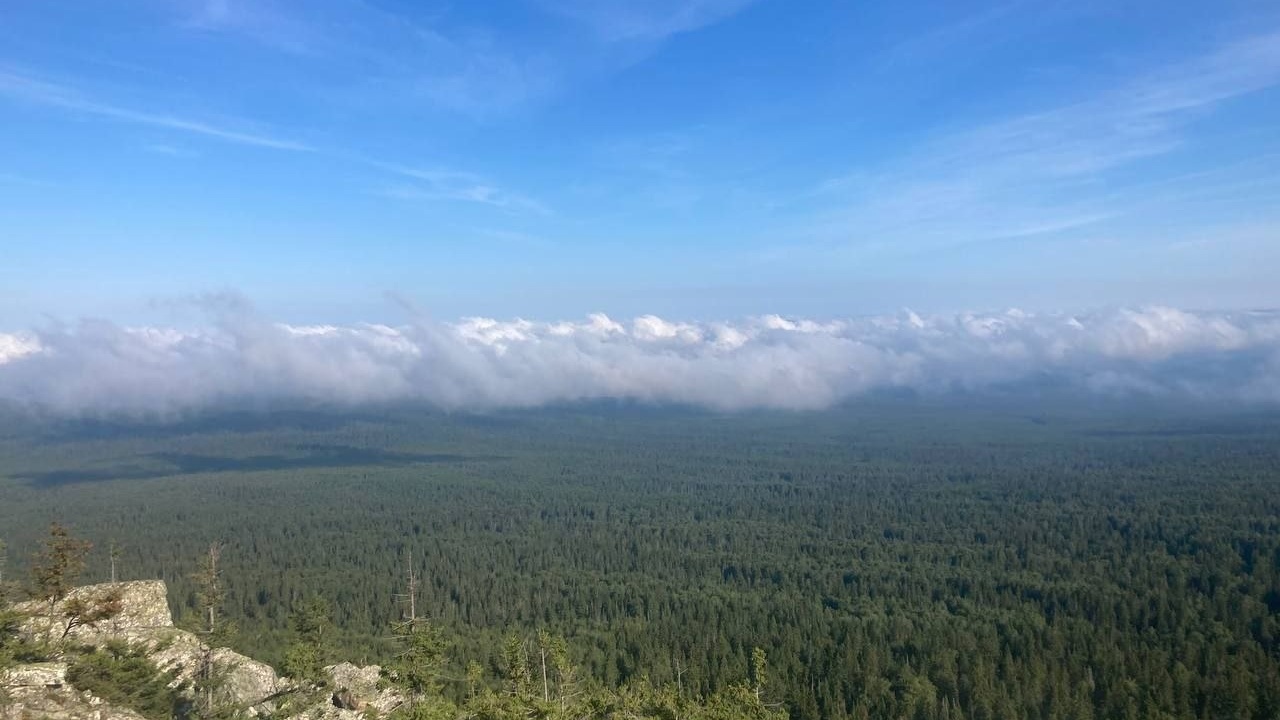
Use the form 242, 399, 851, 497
0, 398, 1280, 720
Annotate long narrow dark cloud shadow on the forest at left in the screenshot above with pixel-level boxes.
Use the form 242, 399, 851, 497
13, 446, 504, 487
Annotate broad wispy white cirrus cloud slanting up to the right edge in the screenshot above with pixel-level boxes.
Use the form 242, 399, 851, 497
809, 32, 1280, 252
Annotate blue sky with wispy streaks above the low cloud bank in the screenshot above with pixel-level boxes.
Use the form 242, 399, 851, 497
0, 0, 1280, 329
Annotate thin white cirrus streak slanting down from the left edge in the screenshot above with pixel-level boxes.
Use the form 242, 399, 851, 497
0, 68, 315, 152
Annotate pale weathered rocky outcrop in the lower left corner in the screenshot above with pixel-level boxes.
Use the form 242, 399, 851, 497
0, 580, 403, 720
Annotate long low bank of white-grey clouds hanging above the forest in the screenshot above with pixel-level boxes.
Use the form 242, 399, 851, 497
0, 302, 1280, 415
